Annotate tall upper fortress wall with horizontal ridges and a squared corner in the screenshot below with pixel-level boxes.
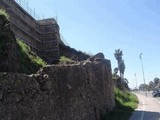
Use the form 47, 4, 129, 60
0, 0, 61, 63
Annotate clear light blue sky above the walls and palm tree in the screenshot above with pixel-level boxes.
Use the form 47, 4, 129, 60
18, 0, 160, 88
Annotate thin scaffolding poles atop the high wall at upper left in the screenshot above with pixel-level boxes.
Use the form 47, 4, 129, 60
14, 0, 41, 20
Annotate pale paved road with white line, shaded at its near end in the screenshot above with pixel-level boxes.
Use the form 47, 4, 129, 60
129, 93, 160, 120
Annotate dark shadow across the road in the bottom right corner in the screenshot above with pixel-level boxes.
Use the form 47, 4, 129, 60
129, 111, 160, 120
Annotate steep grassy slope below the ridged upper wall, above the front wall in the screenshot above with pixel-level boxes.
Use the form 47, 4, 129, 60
17, 39, 46, 74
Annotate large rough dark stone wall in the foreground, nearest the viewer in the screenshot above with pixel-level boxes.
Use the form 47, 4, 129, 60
0, 59, 115, 120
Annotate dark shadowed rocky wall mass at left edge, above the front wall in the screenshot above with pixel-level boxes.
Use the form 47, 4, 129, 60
0, 15, 19, 72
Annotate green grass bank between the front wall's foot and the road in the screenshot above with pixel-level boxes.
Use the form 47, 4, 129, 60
104, 88, 138, 120
